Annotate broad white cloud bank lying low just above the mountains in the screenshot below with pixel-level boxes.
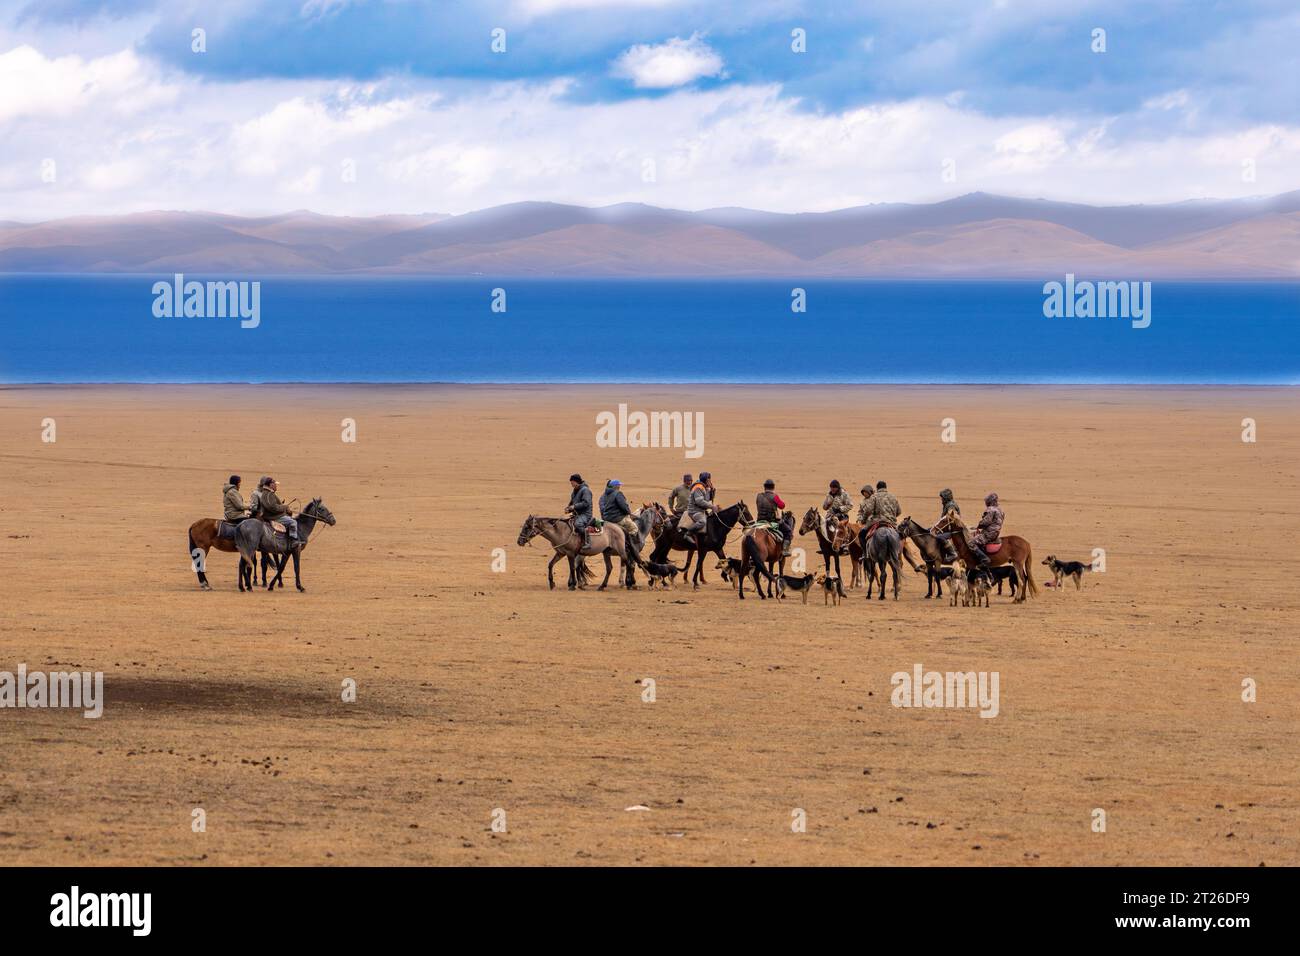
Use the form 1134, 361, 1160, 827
0, 41, 1300, 220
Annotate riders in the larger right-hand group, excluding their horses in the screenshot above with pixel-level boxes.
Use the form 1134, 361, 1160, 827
559, 471, 1006, 568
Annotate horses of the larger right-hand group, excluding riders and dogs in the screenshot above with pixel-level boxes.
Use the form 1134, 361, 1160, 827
517, 501, 1039, 604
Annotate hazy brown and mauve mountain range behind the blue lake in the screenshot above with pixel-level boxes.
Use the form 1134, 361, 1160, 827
0, 191, 1300, 278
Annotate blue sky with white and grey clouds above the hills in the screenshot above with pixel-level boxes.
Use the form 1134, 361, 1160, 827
0, 0, 1300, 221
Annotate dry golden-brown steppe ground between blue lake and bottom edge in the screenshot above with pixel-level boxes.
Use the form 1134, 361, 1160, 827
0, 386, 1300, 866
